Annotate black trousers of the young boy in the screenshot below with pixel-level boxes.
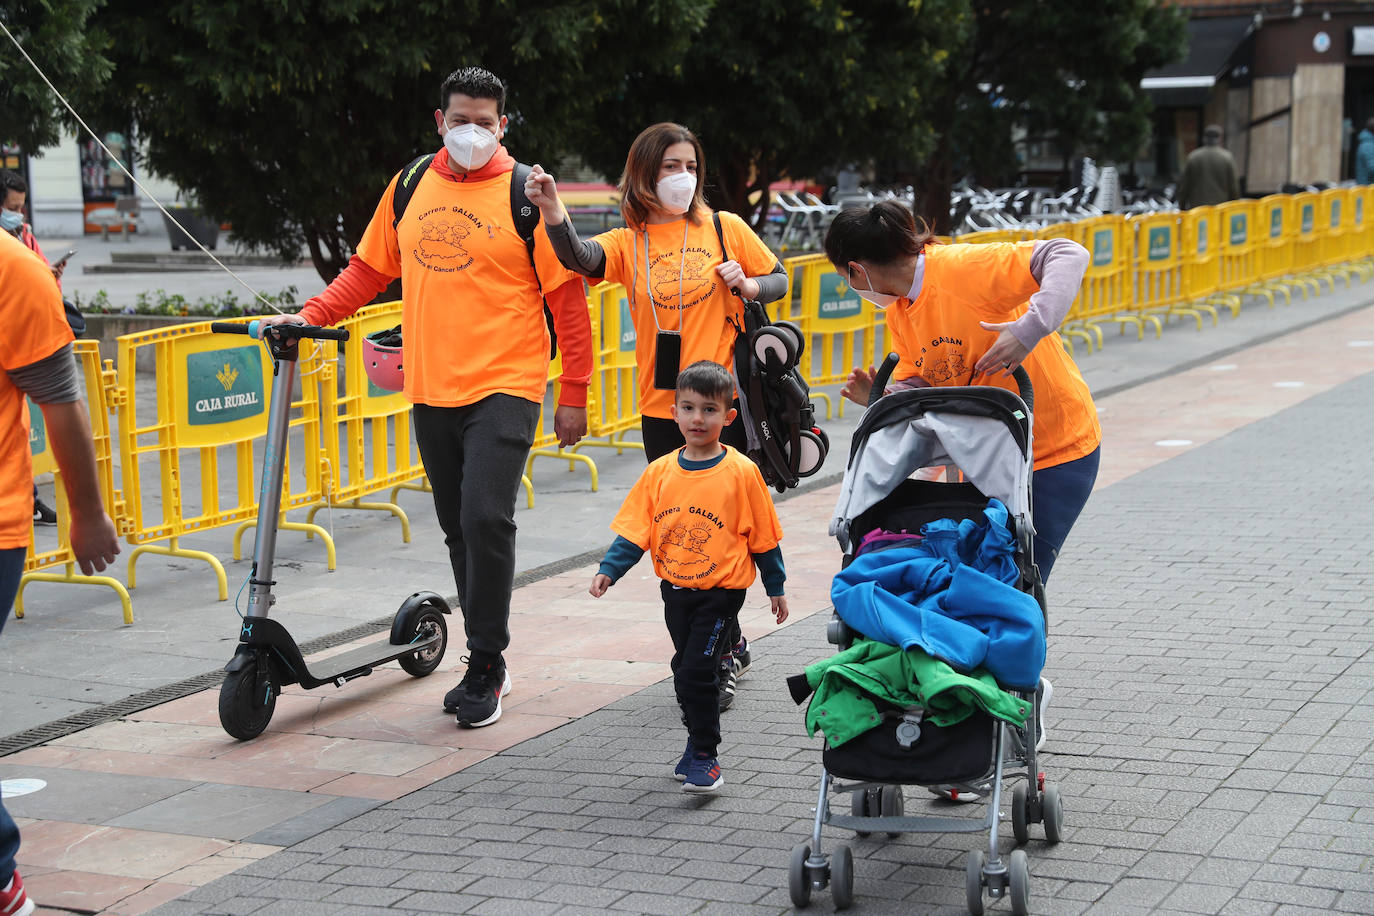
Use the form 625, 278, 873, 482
660, 582, 745, 757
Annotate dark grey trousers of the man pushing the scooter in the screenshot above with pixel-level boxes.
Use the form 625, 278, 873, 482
414, 394, 539, 663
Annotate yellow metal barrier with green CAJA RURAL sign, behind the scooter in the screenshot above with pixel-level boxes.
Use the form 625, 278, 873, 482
117, 319, 335, 602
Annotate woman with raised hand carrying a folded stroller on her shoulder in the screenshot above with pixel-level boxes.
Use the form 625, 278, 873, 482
525, 122, 787, 461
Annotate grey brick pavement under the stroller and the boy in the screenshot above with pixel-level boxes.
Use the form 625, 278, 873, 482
136, 371, 1374, 916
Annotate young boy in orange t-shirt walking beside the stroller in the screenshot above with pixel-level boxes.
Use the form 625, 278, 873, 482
591, 360, 787, 792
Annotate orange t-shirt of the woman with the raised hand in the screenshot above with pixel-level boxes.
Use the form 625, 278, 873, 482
594, 211, 778, 419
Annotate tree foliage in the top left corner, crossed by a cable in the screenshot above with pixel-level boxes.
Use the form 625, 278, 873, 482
0, 0, 110, 152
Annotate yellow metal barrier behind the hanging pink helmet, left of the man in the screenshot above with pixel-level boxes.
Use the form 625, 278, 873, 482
305, 302, 427, 544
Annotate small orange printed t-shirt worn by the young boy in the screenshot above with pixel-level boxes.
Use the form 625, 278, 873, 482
610, 445, 782, 588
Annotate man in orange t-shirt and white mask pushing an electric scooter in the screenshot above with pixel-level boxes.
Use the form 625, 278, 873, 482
264, 67, 592, 728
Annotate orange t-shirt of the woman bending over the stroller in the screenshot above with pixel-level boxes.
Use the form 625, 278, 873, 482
886, 242, 1102, 468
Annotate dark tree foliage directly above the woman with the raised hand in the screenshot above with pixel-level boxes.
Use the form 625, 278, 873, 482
569, 0, 973, 222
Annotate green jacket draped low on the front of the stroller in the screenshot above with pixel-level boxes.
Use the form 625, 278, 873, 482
805, 639, 1031, 747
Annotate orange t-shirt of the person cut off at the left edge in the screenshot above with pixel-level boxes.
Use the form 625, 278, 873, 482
0, 232, 73, 549
